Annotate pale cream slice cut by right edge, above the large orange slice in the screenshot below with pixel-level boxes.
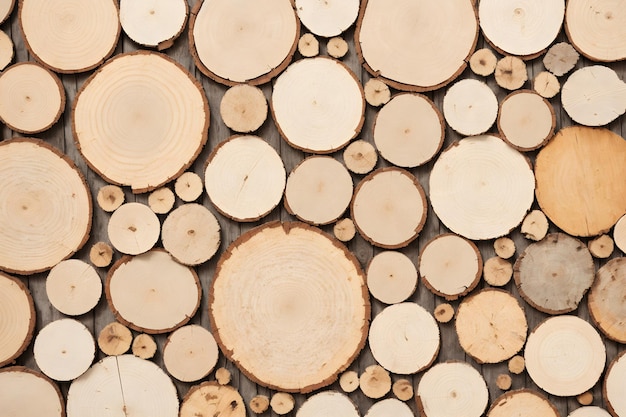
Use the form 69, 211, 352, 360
561, 65, 626, 126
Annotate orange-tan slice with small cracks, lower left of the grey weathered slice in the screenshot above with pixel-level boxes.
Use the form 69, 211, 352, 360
455, 288, 528, 363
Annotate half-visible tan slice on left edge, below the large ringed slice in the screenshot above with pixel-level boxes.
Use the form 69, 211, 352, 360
0, 272, 35, 368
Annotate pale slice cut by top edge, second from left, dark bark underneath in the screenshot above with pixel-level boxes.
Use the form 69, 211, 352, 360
120, 0, 189, 51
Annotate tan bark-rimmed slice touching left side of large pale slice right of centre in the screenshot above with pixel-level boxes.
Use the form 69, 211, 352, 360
351, 168, 426, 249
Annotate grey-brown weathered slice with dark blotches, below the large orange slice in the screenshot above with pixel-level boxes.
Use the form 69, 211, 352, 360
513, 233, 595, 314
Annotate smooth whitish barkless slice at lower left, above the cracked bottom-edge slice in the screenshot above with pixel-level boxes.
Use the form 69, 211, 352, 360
33, 319, 96, 381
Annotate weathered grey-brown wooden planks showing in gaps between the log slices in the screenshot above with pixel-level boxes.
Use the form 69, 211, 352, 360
0, 0, 626, 416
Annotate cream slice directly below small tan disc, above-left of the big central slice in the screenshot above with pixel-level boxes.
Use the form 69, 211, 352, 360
204, 136, 287, 222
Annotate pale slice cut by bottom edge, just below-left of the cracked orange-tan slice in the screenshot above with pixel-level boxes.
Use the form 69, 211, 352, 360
415, 362, 489, 417
